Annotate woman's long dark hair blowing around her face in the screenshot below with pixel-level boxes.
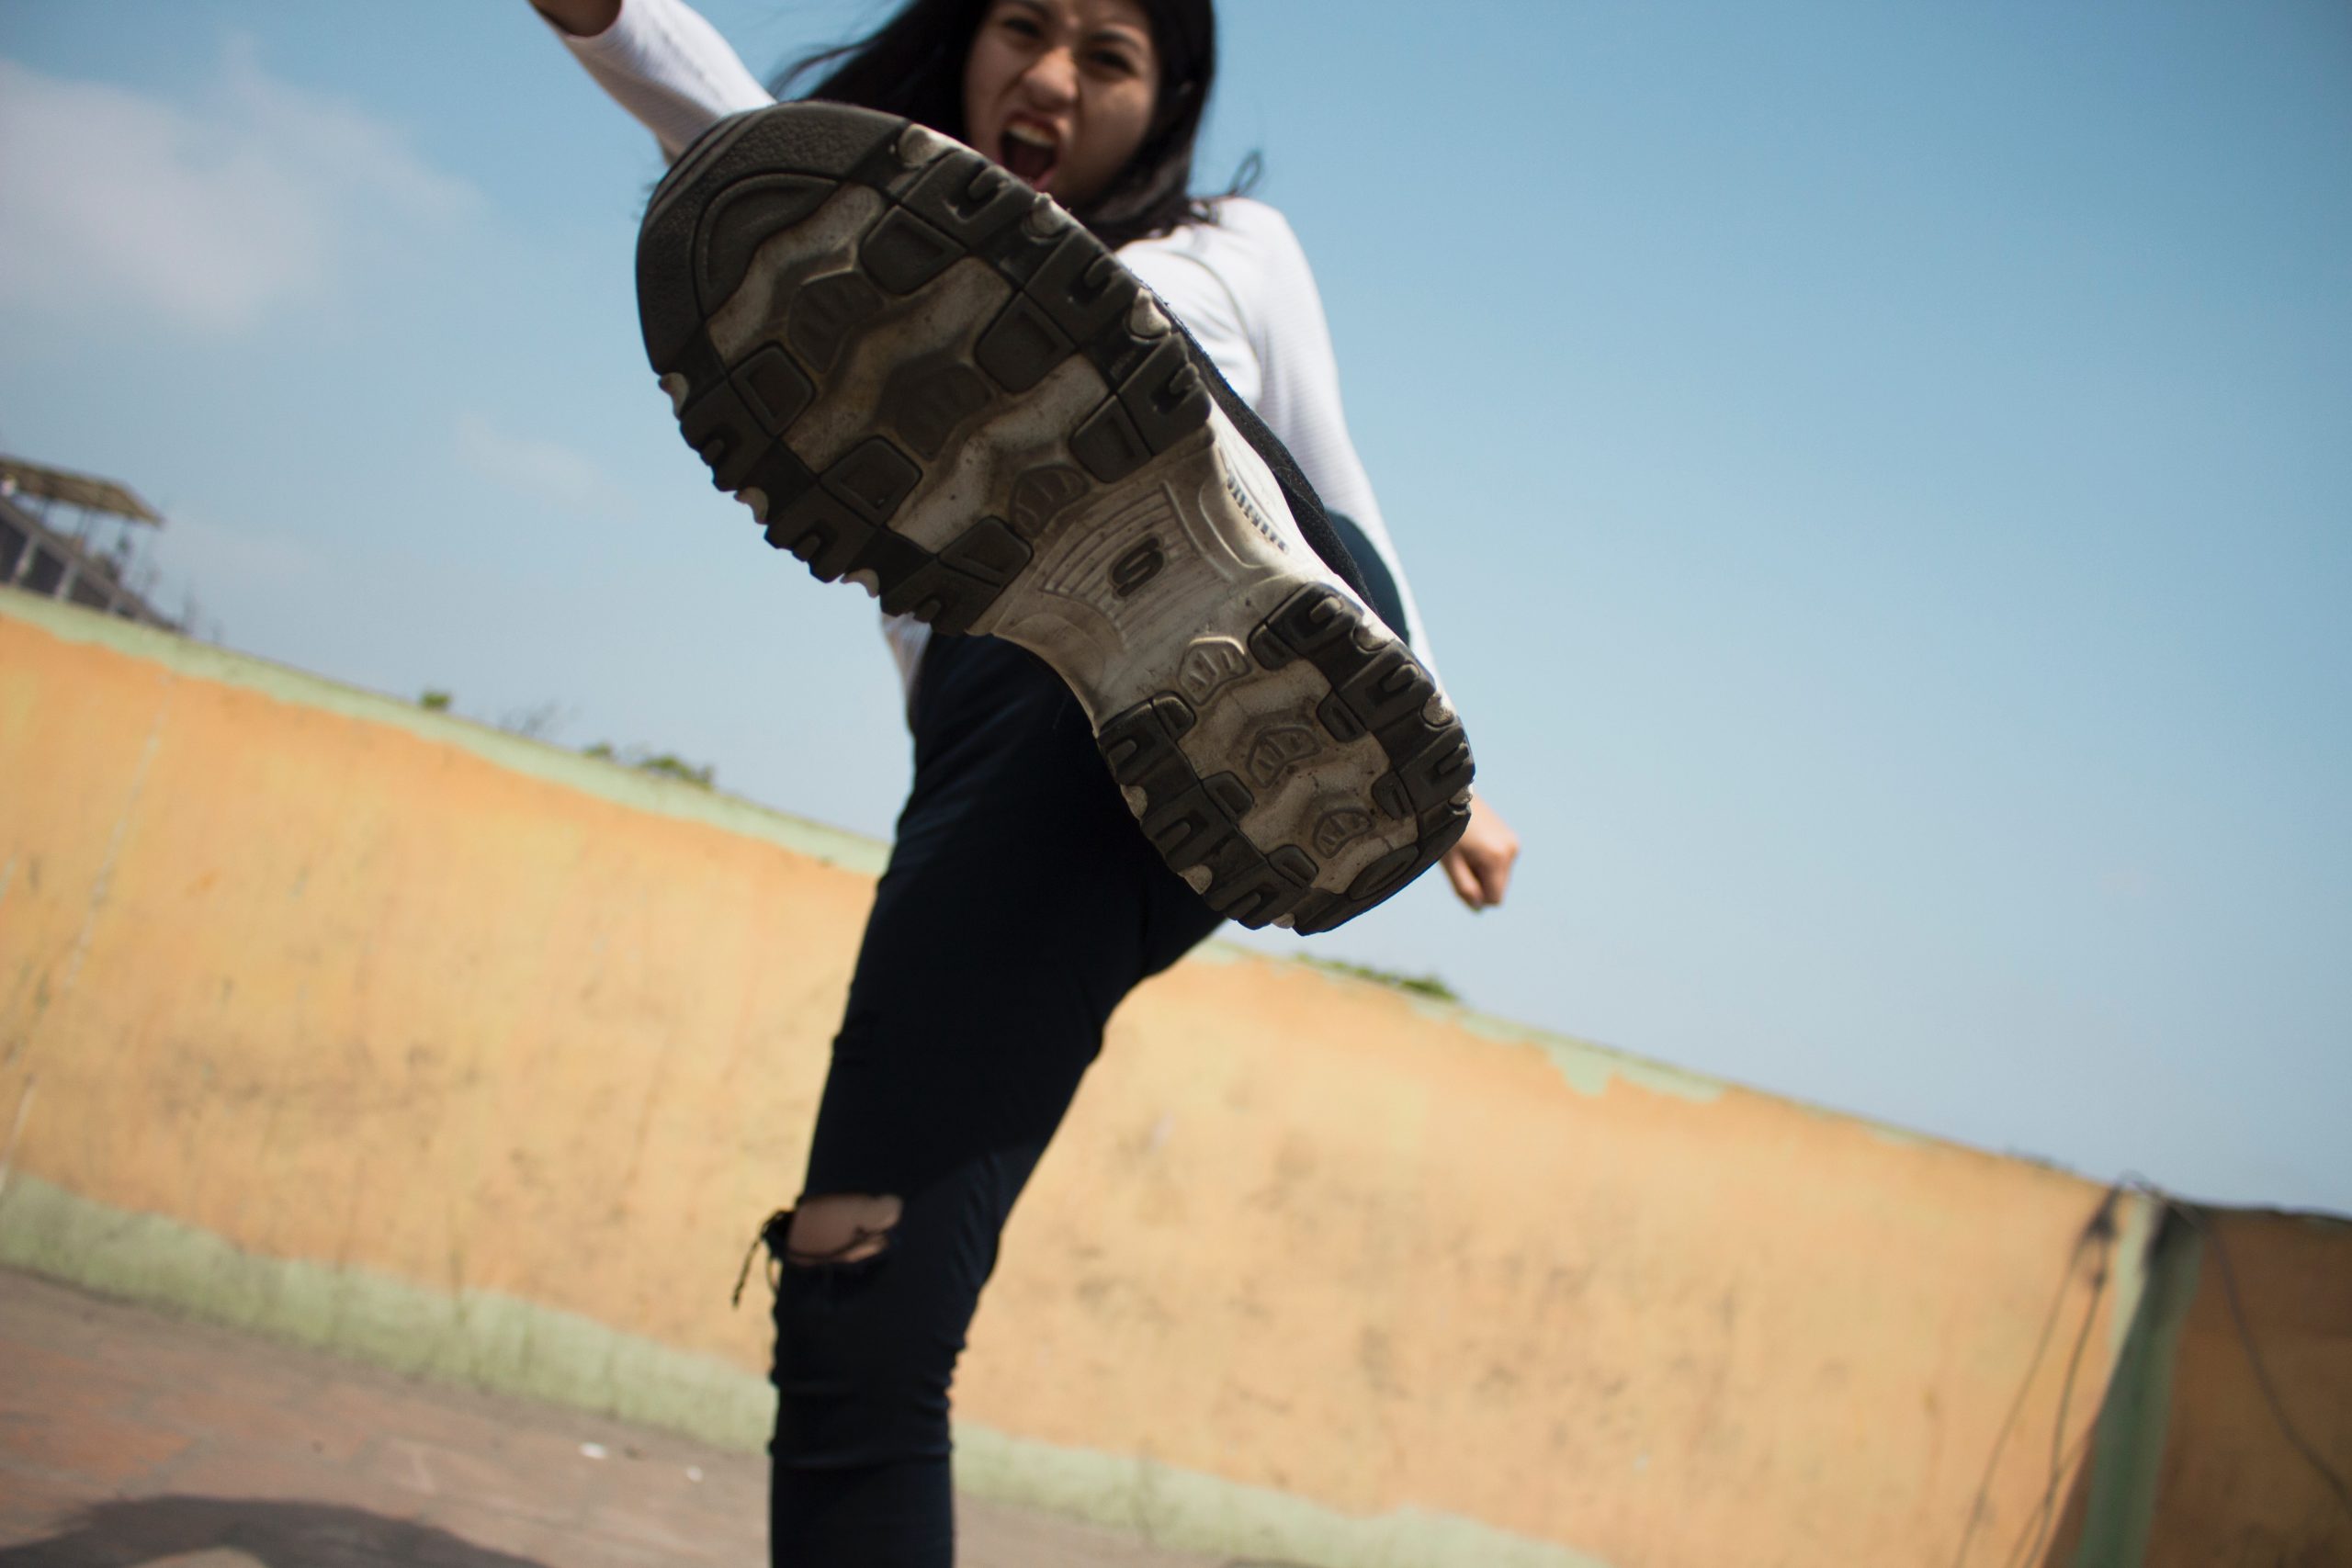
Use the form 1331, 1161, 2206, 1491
774, 0, 1256, 247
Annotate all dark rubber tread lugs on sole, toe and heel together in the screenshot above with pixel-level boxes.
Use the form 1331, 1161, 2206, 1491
638, 106, 1473, 933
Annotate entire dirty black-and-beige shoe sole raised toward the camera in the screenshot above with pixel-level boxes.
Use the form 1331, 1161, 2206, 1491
638, 104, 1470, 931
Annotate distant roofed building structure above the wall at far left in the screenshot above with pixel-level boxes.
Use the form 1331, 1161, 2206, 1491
0, 456, 179, 630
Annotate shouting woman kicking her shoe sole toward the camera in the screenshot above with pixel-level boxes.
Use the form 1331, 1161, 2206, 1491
534, 0, 1517, 1568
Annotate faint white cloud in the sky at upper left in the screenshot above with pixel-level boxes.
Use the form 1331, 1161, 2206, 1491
0, 40, 480, 332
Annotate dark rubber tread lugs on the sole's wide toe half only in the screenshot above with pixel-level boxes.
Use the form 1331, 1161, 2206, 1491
638, 106, 1209, 632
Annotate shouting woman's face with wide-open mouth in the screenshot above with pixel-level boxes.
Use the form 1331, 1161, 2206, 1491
965, 0, 1159, 207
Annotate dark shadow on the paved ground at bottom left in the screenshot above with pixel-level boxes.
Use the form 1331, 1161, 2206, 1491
0, 1497, 543, 1568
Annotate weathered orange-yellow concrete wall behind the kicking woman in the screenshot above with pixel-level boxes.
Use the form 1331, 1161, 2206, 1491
0, 594, 2135, 1568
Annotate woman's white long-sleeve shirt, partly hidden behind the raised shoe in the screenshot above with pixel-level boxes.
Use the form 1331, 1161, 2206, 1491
558, 0, 1435, 684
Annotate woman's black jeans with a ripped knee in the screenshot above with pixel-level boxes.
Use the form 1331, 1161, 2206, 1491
764, 517, 1404, 1568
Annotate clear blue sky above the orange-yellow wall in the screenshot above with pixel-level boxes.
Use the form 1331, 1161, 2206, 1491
0, 0, 2352, 1211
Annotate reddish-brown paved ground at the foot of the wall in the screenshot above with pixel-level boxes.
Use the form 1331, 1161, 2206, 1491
0, 1269, 1216, 1568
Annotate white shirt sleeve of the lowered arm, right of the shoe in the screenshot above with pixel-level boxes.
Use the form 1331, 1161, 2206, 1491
1120, 197, 1437, 674
